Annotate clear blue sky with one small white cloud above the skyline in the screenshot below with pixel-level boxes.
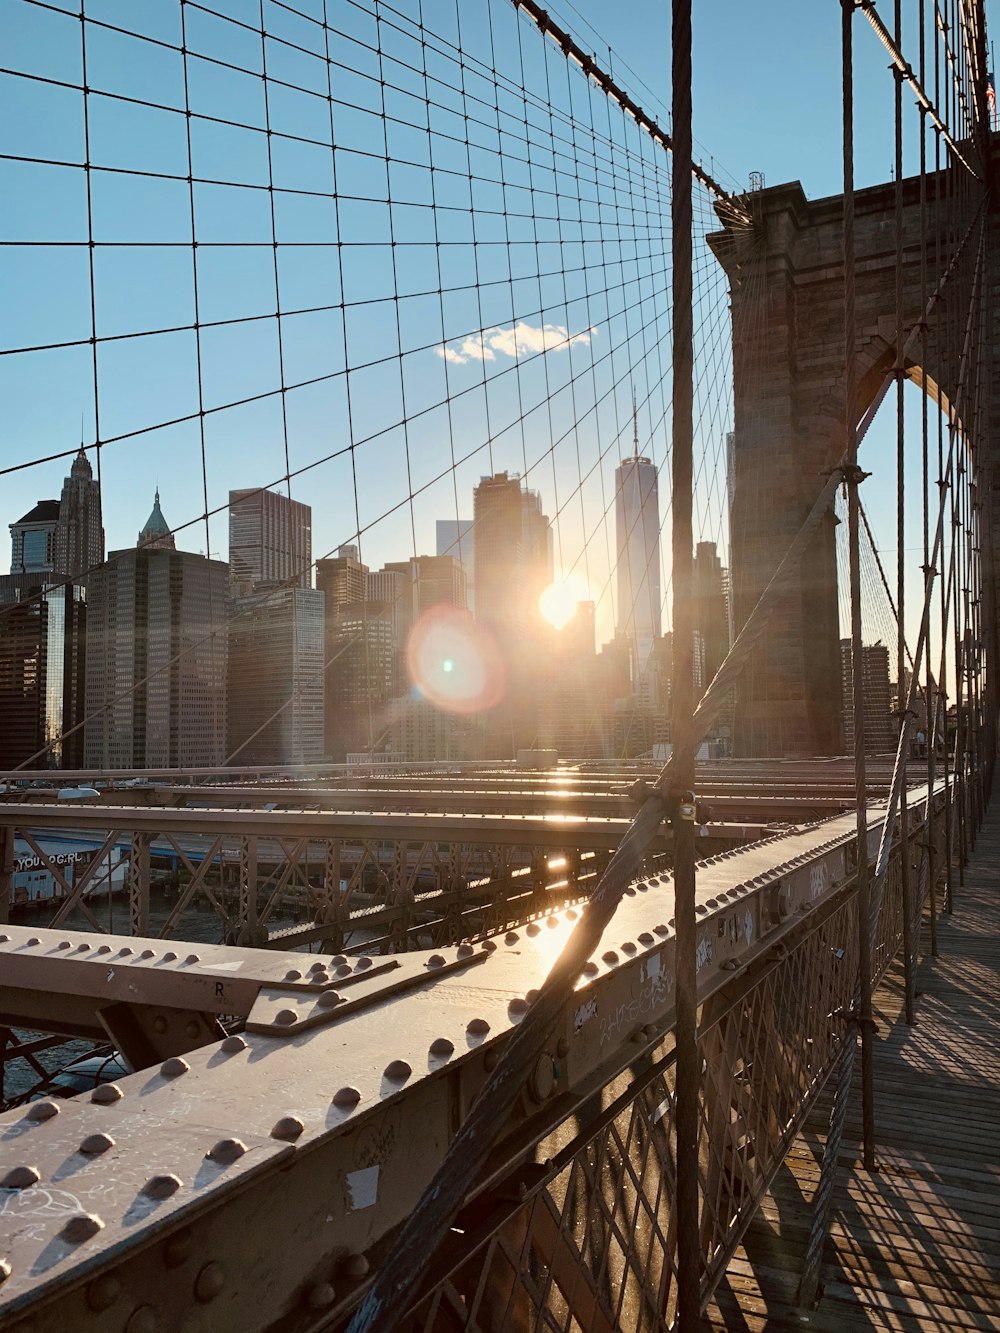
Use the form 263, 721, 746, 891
0, 0, 986, 650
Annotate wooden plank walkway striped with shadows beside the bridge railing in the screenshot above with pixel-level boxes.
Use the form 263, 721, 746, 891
703, 798, 1000, 1333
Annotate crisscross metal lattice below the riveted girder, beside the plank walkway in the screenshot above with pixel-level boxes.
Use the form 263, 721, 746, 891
378, 805, 944, 1333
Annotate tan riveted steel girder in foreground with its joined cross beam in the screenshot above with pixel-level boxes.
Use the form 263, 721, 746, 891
0, 792, 938, 1333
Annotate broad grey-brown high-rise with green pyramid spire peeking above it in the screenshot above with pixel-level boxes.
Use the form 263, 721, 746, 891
84, 493, 229, 768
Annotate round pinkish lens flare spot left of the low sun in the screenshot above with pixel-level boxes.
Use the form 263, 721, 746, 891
407, 605, 507, 713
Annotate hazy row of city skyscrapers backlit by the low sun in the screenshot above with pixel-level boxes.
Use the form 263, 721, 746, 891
0, 442, 746, 768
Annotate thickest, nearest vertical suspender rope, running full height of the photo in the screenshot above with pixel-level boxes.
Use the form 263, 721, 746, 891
671, 0, 701, 1333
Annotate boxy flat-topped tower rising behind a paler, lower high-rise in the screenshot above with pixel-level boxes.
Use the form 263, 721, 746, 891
229, 489, 312, 593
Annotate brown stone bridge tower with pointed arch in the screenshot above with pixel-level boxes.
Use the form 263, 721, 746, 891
708, 153, 1000, 756
